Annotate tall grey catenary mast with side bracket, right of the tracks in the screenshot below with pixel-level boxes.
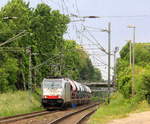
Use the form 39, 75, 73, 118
102, 22, 111, 103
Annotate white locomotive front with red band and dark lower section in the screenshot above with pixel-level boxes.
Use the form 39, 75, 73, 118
42, 79, 64, 108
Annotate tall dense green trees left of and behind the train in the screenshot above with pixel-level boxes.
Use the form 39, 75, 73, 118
0, 0, 101, 92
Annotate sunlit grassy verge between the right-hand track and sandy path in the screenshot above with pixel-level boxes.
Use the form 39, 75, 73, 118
88, 93, 150, 124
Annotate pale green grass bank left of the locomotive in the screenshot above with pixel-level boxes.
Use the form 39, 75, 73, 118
0, 91, 43, 117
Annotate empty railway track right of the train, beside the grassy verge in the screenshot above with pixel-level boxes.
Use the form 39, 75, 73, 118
48, 103, 99, 124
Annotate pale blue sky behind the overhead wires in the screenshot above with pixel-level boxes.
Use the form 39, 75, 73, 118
0, 0, 150, 80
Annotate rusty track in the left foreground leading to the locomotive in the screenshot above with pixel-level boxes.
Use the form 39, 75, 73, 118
0, 110, 56, 124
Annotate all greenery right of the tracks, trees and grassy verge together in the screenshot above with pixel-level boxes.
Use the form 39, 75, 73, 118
89, 43, 150, 124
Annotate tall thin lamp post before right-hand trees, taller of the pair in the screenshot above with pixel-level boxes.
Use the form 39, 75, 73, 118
128, 25, 136, 96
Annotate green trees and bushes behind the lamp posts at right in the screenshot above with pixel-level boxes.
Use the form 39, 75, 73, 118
117, 43, 150, 100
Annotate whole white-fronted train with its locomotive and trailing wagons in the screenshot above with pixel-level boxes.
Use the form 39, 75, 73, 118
42, 78, 91, 109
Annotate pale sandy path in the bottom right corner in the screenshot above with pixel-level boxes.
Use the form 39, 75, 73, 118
108, 111, 150, 124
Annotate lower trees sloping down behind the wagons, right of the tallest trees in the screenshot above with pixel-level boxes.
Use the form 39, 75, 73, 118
63, 40, 101, 81
